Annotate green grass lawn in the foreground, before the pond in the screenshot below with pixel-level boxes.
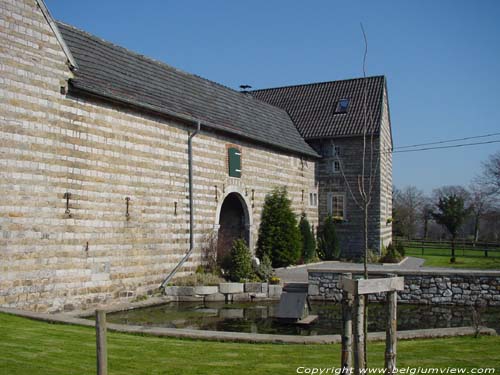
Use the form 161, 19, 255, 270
0, 314, 500, 375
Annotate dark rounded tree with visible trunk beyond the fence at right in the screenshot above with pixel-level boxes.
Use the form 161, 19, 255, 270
432, 194, 469, 263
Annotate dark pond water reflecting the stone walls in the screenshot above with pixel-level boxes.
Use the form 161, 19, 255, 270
107, 301, 500, 336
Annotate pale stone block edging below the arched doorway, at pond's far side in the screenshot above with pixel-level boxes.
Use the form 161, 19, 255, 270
165, 283, 282, 302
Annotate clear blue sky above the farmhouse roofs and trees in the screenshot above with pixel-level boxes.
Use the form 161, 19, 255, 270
46, 0, 500, 192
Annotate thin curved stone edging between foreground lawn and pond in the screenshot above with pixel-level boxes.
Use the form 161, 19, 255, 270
0, 308, 496, 344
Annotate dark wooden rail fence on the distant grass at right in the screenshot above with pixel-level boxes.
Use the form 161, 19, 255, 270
394, 237, 500, 257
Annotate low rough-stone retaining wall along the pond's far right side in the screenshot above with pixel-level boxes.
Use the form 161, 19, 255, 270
308, 269, 500, 306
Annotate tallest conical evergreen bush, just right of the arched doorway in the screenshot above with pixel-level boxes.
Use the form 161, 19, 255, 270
257, 188, 301, 267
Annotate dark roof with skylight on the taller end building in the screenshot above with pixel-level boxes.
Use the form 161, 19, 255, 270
251, 76, 386, 140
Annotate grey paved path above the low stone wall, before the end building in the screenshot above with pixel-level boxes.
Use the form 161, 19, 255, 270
276, 257, 425, 283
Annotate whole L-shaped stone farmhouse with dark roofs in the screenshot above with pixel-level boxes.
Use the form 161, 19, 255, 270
0, 0, 392, 311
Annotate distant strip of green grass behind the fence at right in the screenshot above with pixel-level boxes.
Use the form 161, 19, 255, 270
405, 247, 500, 270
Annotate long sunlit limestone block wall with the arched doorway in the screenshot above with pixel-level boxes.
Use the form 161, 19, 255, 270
0, 0, 317, 311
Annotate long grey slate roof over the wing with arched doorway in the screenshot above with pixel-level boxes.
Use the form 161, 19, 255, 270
57, 22, 318, 157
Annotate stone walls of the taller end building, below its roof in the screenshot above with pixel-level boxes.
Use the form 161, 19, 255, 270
309, 85, 392, 258
